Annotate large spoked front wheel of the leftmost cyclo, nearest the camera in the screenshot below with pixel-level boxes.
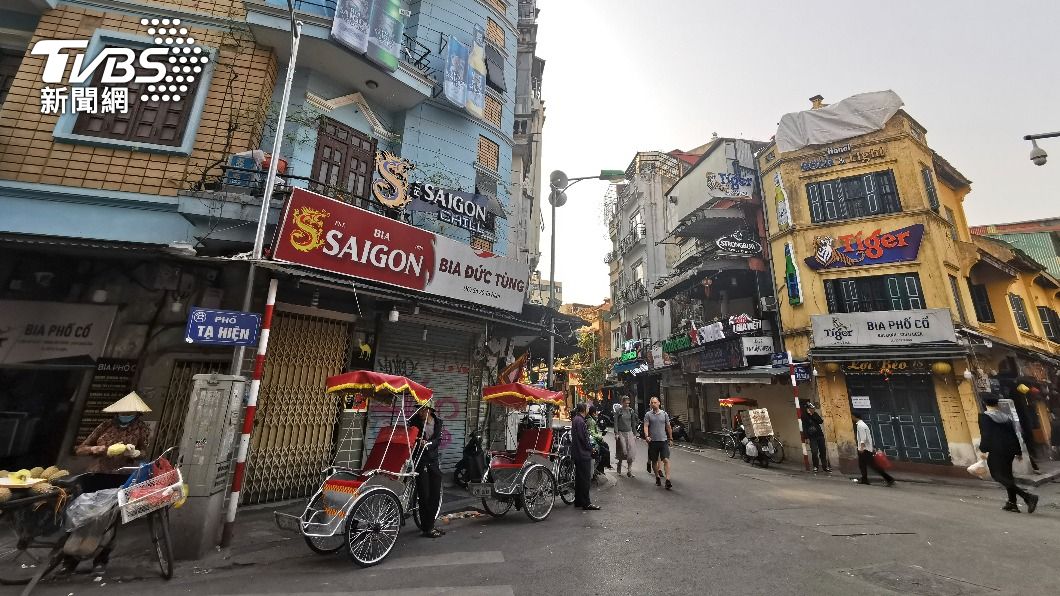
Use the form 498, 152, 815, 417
346, 489, 402, 567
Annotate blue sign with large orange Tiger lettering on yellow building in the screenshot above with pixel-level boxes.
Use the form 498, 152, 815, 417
806, 224, 924, 269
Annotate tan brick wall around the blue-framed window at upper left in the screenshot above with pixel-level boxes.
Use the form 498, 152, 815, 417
0, 0, 277, 196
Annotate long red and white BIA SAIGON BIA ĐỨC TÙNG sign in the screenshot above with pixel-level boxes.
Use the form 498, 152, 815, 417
272, 189, 530, 313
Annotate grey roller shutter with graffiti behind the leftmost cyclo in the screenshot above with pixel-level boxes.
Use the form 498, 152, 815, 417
365, 321, 474, 471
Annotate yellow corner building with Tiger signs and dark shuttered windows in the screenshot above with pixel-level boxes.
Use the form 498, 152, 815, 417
758, 99, 1058, 473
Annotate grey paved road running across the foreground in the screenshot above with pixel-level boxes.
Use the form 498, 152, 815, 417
29, 436, 1060, 596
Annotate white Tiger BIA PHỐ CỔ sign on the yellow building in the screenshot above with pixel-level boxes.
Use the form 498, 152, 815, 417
810, 309, 957, 347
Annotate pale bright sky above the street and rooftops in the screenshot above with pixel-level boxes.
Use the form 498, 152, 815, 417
537, 0, 1060, 303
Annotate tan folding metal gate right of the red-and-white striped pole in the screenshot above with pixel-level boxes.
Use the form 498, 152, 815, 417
241, 311, 350, 504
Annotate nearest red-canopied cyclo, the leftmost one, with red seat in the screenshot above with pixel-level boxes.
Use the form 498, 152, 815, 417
275, 370, 442, 567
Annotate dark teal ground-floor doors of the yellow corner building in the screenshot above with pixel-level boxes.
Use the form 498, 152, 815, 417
847, 374, 950, 463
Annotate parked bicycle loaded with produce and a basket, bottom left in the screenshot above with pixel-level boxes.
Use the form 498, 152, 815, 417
0, 448, 183, 596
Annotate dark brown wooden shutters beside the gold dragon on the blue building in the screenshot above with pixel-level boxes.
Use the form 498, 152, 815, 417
311, 118, 375, 198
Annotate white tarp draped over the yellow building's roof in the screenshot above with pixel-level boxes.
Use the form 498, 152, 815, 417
777, 89, 903, 153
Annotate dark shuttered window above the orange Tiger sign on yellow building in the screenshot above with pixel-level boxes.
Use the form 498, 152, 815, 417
806, 170, 902, 223
